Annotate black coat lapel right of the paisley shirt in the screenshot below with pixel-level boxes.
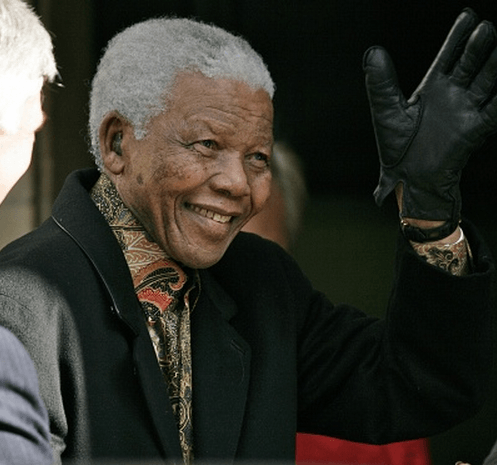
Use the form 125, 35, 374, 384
192, 271, 251, 462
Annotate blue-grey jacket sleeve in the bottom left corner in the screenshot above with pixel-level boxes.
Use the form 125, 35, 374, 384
0, 327, 52, 465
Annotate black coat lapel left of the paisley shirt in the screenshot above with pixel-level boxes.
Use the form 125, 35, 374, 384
52, 170, 181, 463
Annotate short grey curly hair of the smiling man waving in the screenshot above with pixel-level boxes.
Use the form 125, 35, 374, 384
89, 18, 274, 169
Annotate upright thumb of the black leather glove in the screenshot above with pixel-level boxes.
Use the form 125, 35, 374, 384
363, 47, 405, 109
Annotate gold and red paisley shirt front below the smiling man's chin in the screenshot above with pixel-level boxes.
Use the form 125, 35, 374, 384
91, 174, 199, 464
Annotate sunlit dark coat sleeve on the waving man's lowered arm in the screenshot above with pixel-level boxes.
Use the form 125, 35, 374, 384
0, 267, 89, 464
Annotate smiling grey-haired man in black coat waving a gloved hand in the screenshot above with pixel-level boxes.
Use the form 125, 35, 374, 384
0, 10, 497, 463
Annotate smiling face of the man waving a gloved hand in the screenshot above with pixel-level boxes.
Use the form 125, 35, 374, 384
112, 73, 273, 268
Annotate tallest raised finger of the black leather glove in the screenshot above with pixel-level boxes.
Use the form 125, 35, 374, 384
430, 8, 478, 74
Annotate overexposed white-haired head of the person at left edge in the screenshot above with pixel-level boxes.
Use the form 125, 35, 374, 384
0, 0, 57, 202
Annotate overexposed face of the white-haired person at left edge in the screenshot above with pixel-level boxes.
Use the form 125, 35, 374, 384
0, 91, 45, 203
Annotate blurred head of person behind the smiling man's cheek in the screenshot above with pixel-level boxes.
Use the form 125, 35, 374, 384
243, 141, 307, 250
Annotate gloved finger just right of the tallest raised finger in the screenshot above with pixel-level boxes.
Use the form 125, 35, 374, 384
452, 21, 496, 87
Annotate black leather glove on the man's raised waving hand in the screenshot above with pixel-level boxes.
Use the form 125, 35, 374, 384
364, 9, 497, 242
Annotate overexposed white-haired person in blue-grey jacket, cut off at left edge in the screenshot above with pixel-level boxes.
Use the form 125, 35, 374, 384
0, 0, 56, 465
